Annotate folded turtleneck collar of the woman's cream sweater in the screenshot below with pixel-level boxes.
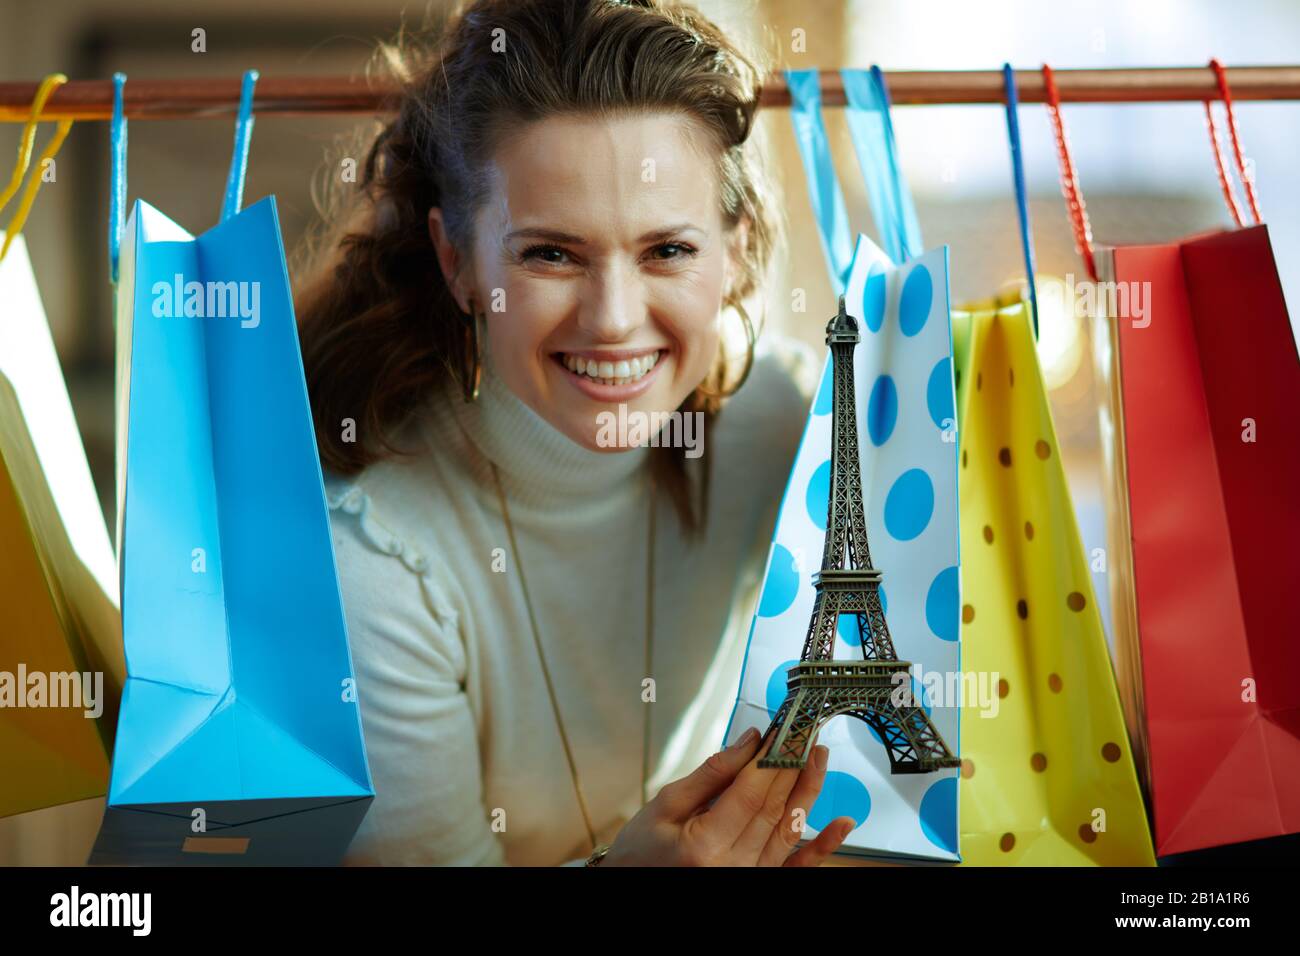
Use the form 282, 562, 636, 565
447, 355, 650, 502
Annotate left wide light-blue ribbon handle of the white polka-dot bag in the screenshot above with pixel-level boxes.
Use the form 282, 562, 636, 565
785, 70, 853, 295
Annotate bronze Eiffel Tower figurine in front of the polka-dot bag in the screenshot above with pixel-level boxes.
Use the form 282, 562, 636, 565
758, 295, 961, 774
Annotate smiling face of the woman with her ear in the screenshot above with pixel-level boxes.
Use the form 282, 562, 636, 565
429, 113, 735, 450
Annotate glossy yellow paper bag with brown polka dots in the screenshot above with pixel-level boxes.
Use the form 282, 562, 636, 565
953, 297, 1156, 866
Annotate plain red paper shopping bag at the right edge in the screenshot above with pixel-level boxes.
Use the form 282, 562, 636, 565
1099, 226, 1300, 856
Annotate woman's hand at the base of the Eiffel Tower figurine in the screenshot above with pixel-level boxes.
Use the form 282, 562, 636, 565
601, 728, 857, 866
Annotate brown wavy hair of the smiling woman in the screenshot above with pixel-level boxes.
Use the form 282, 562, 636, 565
294, 0, 780, 532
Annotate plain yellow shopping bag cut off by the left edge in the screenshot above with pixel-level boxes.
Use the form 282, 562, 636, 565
0, 233, 125, 817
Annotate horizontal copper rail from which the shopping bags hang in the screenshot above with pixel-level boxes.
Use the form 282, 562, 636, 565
0, 66, 1300, 122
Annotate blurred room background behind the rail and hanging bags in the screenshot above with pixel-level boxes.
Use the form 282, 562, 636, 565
0, 0, 1300, 865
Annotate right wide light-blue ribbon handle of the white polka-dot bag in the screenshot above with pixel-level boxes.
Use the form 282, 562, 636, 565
840, 66, 924, 263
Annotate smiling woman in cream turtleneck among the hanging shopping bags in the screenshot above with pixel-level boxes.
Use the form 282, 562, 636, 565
296, 0, 852, 866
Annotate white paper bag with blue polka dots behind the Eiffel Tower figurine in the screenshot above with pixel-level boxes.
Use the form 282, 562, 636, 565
725, 235, 961, 861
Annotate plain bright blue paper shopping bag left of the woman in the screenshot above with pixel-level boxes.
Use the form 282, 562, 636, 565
91, 72, 374, 865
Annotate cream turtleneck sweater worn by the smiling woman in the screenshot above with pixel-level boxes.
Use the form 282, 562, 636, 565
326, 339, 820, 865
